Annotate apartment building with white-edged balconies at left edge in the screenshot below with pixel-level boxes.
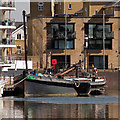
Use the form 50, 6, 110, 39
0, 0, 16, 66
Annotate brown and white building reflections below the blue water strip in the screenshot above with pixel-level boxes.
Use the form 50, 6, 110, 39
0, 100, 118, 118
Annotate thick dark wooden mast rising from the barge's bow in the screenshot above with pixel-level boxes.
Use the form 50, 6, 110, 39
23, 10, 28, 72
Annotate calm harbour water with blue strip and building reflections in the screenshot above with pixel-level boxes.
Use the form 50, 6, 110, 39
0, 90, 119, 119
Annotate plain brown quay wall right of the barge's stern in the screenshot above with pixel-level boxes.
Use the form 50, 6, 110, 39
98, 71, 120, 89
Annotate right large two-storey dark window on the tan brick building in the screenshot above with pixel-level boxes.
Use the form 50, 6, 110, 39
85, 23, 113, 49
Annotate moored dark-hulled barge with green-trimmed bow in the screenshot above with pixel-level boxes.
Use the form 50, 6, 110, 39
15, 74, 106, 96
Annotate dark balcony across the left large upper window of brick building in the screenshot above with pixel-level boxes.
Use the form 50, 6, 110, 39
53, 31, 76, 39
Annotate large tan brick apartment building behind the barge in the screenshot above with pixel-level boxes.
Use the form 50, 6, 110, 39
28, 0, 120, 69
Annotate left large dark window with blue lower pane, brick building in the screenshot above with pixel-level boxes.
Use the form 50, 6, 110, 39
51, 24, 75, 49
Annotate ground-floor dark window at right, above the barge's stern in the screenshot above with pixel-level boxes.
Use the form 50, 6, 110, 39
89, 55, 108, 69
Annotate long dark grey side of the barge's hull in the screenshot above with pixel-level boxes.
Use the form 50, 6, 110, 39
24, 79, 77, 96
